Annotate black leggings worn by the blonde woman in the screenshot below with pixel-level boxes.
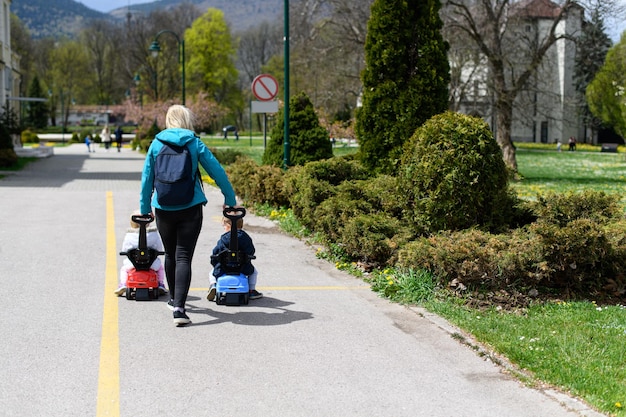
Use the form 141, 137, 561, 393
155, 204, 202, 309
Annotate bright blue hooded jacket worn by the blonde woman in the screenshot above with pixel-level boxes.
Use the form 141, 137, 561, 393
139, 128, 237, 214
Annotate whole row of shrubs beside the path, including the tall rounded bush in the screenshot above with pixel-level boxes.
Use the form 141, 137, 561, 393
218, 115, 626, 299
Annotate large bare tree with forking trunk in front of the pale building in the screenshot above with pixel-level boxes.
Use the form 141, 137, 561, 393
442, 0, 612, 171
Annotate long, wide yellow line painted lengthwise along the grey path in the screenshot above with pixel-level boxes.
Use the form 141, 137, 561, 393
96, 191, 120, 417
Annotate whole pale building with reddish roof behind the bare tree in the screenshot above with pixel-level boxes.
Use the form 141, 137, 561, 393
450, 0, 597, 143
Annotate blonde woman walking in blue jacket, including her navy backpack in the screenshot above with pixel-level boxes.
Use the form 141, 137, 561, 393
139, 105, 236, 326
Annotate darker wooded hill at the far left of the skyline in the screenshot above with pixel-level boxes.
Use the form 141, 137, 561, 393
11, 0, 112, 38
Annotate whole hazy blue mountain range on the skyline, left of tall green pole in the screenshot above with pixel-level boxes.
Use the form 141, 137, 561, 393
11, 0, 283, 38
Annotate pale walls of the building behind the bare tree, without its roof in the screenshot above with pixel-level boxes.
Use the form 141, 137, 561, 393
450, 1, 584, 143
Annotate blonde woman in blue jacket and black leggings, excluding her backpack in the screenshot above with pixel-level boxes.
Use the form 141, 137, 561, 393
139, 105, 236, 326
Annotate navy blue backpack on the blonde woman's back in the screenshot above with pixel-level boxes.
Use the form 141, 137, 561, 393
154, 141, 197, 206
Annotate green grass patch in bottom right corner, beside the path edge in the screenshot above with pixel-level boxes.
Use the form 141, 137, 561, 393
425, 300, 626, 416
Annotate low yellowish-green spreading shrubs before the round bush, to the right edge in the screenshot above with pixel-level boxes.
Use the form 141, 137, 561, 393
397, 192, 626, 299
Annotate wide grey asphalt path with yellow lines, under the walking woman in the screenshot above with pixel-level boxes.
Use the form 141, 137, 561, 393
0, 145, 601, 417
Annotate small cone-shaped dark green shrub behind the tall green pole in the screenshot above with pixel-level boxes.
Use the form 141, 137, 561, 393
263, 93, 333, 166
